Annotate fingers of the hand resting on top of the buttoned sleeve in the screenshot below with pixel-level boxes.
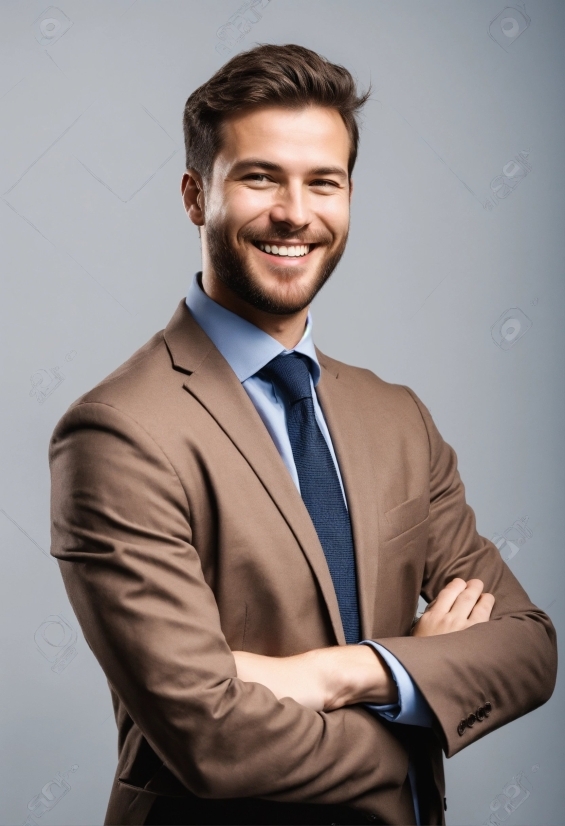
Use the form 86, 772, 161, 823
410, 577, 494, 637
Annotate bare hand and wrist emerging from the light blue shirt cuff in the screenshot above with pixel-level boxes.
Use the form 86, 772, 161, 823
232, 645, 398, 711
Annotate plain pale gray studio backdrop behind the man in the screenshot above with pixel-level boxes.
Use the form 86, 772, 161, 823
0, 0, 565, 826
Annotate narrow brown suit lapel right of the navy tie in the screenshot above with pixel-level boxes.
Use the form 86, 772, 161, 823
316, 347, 379, 639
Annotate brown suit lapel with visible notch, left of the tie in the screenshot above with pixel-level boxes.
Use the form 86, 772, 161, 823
164, 300, 346, 645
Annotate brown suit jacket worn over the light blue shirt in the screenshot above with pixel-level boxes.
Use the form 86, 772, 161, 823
50, 301, 557, 824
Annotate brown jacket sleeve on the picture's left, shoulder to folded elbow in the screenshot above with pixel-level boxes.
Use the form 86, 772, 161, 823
49, 401, 408, 810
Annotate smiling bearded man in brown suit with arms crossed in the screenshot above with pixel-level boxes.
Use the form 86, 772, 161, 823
50, 45, 556, 824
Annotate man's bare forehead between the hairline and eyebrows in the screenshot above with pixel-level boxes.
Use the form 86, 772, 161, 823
217, 106, 350, 170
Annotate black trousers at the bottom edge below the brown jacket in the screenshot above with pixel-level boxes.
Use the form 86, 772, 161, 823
145, 795, 382, 826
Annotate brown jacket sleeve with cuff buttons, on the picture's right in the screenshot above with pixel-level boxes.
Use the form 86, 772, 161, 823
368, 388, 557, 757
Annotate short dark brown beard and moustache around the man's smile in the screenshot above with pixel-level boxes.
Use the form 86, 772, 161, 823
206, 217, 349, 315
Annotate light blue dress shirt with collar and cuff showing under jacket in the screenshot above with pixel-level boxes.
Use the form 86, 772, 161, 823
186, 272, 432, 826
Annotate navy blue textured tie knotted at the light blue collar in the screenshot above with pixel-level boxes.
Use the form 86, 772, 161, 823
259, 352, 360, 644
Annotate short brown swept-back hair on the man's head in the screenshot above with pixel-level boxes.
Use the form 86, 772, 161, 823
183, 43, 371, 182
